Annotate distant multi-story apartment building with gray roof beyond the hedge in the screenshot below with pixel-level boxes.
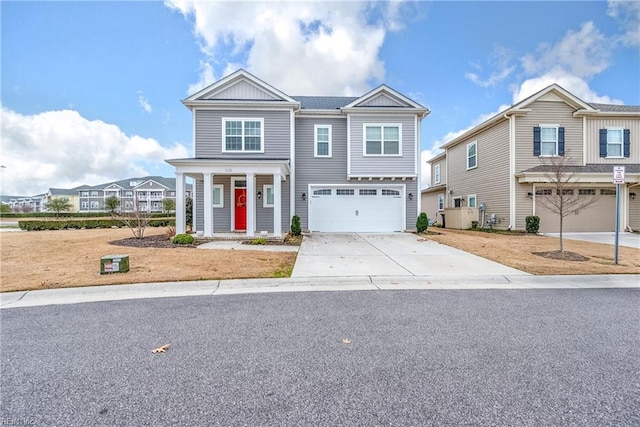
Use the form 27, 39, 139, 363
75, 176, 191, 212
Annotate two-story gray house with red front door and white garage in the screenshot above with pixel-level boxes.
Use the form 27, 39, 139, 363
167, 70, 429, 236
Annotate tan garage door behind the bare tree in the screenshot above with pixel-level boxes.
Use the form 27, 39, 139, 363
536, 188, 616, 233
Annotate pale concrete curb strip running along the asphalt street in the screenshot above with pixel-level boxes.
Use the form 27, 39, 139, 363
0, 275, 640, 309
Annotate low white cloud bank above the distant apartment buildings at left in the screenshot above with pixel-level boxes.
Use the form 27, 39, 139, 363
0, 107, 188, 195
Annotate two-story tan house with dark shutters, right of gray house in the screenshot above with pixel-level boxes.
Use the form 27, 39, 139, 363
422, 84, 640, 232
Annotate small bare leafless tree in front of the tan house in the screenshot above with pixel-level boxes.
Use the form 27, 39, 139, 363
536, 156, 598, 252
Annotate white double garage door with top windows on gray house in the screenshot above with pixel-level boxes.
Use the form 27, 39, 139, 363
309, 186, 404, 232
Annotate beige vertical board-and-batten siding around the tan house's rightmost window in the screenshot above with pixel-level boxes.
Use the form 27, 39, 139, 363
585, 117, 640, 165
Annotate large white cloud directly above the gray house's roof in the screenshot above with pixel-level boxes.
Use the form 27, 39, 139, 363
165, 0, 405, 95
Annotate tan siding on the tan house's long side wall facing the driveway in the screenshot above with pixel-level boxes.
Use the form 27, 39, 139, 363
445, 120, 510, 228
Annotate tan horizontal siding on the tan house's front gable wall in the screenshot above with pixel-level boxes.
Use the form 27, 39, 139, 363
514, 101, 583, 230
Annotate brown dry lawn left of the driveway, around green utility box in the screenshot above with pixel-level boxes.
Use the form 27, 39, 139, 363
0, 228, 296, 292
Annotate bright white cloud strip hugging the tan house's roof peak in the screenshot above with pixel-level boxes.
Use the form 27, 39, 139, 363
513, 68, 623, 104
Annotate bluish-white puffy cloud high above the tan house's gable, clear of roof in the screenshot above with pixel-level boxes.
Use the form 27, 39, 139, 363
521, 21, 612, 78
